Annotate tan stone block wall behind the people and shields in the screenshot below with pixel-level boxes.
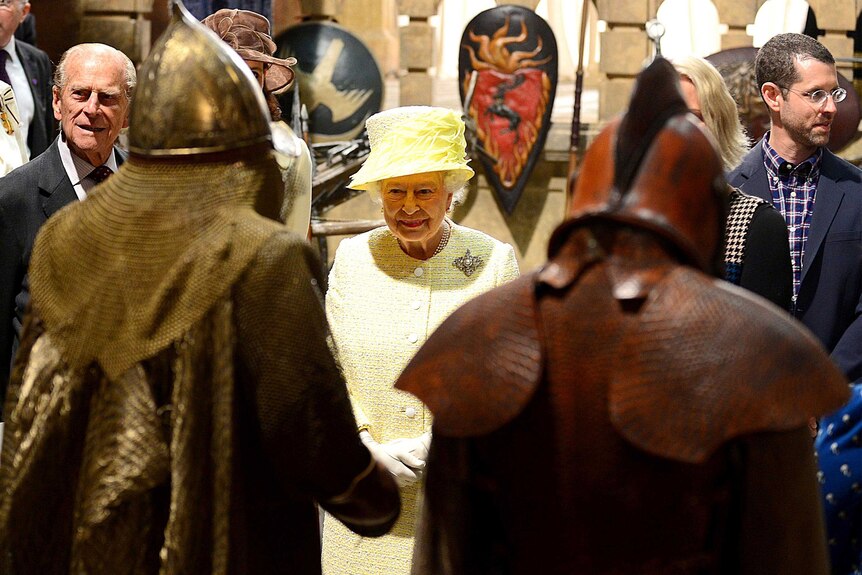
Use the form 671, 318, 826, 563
32, 0, 862, 271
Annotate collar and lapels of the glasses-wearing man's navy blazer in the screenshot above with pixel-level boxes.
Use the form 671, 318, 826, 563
728, 142, 844, 284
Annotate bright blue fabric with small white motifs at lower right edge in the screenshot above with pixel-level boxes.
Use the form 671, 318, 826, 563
814, 385, 862, 575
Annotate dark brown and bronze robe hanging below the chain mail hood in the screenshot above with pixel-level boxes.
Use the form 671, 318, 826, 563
0, 228, 368, 575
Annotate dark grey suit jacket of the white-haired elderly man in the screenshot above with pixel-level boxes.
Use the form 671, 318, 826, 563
0, 139, 125, 405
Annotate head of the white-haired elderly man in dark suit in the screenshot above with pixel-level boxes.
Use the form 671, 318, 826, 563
53, 50, 129, 166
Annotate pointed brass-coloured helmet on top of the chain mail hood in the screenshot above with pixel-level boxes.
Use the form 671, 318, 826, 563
129, 1, 271, 157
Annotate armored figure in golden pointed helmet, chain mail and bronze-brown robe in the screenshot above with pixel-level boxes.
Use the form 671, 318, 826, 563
0, 3, 399, 575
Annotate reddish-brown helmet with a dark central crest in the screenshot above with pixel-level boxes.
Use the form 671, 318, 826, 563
548, 58, 727, 274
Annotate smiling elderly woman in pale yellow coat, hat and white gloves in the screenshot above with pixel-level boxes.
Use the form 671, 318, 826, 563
323, 106, 518, 575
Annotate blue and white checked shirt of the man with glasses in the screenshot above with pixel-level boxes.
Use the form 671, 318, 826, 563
763, 132, 823, 301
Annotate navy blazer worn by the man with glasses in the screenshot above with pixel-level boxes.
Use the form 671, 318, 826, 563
728, 143, 862, 381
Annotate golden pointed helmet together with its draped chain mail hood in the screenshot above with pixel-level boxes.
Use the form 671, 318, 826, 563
30, 3, 282, 377
